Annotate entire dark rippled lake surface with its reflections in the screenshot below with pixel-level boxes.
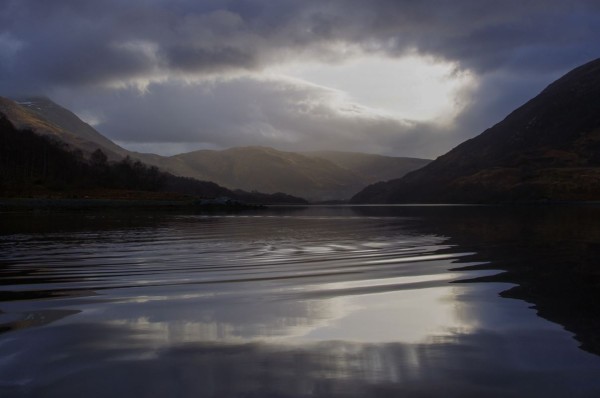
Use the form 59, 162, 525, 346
0, 206, 600, 398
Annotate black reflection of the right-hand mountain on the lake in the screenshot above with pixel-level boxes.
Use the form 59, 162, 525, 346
355, 204, 600, 354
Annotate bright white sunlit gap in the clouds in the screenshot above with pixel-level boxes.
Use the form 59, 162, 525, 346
273, 56, 476, 121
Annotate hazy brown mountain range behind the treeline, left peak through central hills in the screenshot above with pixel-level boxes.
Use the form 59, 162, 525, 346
0, 97, 429, 200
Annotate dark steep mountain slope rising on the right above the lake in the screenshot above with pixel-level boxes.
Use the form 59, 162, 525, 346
351, 59, 600, 203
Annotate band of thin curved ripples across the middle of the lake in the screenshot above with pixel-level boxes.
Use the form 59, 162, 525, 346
0, 216, 465, 300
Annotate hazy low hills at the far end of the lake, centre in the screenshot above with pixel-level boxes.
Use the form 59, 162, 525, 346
162, 147, 428, 200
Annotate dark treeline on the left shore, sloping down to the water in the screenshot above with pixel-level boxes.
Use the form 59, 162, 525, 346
0, 116, 305, 203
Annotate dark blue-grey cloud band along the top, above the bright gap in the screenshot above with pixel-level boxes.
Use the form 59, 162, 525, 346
0, 0, 600, 88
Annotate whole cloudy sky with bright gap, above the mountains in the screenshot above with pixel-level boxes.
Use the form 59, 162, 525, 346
0, 0, 600, 158
